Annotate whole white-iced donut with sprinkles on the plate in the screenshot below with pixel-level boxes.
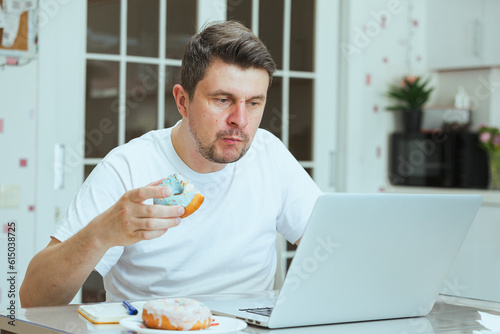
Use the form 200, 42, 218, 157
142, 298, 212, 331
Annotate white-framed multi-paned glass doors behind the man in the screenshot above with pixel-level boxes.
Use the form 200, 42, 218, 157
84, 0, 339, 292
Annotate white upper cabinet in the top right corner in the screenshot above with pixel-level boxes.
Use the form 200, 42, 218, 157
427, 0, 500, 70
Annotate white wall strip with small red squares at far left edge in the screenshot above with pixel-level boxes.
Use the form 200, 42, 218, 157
0, 61, 39, 310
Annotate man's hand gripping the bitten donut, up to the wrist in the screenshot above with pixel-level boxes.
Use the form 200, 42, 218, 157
90, 180, 184, 248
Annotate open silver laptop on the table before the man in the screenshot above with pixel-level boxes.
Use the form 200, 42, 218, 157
206, 193, 482, 328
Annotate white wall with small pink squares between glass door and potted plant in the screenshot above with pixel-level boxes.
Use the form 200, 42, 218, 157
338, 0, 426, 192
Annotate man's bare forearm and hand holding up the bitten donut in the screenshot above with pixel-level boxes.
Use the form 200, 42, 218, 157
19, 181, 184, 307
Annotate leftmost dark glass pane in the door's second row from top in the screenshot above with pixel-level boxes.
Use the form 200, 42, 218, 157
85, 60, 119, 158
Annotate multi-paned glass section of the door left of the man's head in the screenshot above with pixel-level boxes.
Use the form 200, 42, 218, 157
84, 0, 198, 177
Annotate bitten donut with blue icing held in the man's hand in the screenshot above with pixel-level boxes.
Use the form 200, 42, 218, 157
153, 173, 205, 218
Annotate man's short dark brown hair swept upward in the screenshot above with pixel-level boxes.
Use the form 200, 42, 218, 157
181, 21, 276, 100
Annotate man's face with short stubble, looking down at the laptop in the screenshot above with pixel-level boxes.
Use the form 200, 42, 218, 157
187, 60, 269, 164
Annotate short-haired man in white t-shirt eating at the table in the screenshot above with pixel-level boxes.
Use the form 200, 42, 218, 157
20, 22, 320, 307
